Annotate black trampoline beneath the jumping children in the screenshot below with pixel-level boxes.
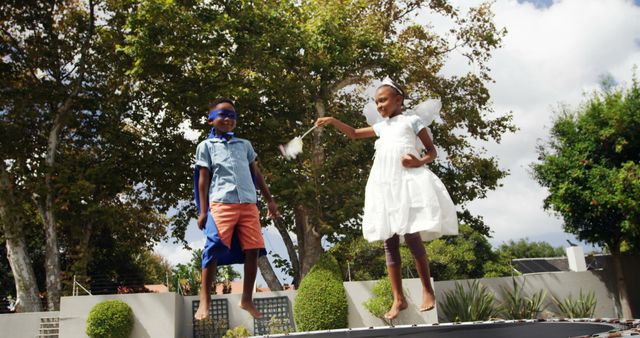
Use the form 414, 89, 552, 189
262, 320, 640, 338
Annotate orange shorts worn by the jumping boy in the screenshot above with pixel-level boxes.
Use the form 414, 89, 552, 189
211, 202, 264, 250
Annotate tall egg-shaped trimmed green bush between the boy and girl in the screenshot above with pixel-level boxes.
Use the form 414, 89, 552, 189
293, 254, 348, 331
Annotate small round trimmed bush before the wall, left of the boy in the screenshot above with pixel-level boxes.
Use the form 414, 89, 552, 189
87, 300, 133, 338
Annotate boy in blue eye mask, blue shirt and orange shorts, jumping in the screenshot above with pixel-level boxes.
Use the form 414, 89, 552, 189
195, 98, 278, 320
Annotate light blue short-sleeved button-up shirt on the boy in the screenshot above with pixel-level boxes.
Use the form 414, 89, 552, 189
196, 137, 257, 203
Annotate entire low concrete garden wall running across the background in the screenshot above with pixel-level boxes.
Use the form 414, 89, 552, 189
0, 261, 640, 338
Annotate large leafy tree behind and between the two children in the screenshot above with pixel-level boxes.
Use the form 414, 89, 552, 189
123, 0, 513, 284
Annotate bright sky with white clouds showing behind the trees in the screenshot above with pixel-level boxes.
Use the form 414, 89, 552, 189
156, 0, 640, 285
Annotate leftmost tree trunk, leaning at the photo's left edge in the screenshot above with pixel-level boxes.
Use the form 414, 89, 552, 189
0, 166, 42, 312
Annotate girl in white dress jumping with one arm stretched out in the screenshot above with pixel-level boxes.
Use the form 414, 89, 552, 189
316, 80, 458, 319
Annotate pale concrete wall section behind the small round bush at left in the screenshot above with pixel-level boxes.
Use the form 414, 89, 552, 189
60, 293, 182, 338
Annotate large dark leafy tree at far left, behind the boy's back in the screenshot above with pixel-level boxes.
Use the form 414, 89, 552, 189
0, 0, 190, 311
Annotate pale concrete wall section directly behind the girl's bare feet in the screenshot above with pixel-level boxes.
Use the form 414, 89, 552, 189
344, 278, 438, 328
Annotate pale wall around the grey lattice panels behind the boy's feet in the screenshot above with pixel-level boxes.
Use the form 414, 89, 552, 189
177, 291, 297, 338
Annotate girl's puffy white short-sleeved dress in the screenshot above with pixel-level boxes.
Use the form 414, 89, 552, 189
362, 114, 458, 242
